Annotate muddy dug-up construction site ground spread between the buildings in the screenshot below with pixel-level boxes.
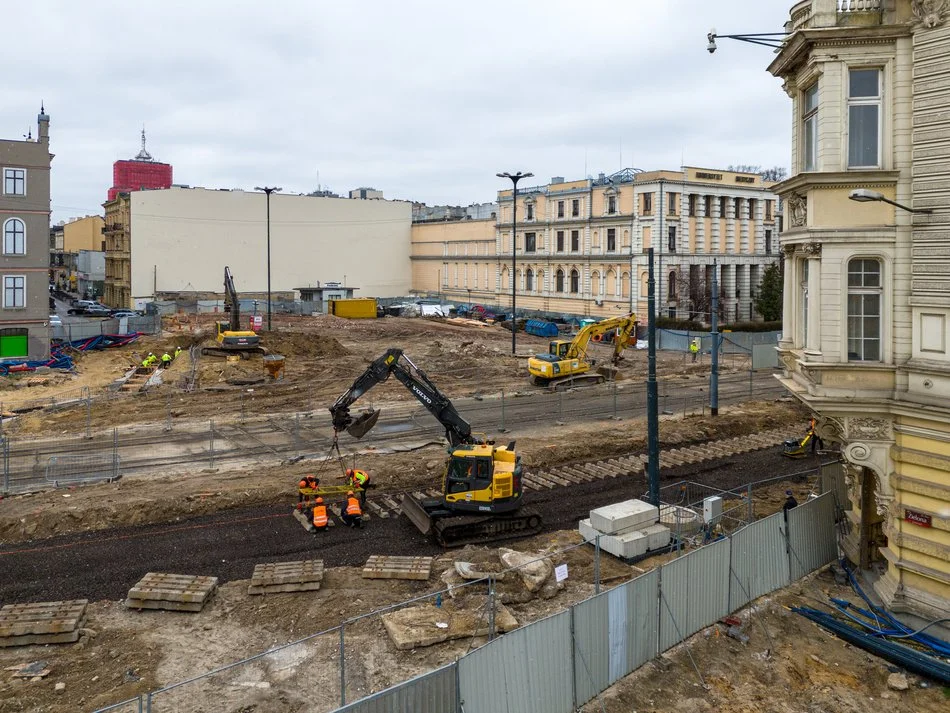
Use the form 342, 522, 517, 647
0, 315, 948, 713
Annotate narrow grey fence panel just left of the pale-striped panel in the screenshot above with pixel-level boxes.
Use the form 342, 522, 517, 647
574, 592, 610, 706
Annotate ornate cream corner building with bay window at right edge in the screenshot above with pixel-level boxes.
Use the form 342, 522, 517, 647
769, 0, 950, 618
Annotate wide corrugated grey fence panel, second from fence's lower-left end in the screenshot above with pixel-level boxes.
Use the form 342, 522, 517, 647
458, 611, 574, 713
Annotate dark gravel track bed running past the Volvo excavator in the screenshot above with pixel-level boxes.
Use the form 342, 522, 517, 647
0, 448, 818, 604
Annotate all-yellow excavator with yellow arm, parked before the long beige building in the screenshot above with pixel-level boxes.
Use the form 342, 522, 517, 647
528, 312, 639, 390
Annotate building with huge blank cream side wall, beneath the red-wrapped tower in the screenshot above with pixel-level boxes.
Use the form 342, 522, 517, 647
104, 186, 411, 308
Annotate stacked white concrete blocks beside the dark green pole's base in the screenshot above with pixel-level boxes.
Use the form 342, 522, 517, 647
577, 500, 670, 560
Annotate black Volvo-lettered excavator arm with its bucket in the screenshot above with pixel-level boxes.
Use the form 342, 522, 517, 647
330, 348, 479, 448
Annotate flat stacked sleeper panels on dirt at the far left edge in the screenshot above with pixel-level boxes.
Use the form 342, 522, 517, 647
0, 599, 89, 647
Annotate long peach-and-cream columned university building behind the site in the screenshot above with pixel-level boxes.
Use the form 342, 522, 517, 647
413, 167, 778, 321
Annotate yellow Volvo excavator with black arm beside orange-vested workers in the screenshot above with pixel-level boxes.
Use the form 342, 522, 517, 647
330, 348, 541, 547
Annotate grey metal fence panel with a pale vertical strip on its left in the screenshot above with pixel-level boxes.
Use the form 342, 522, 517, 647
607, 569, 660, 684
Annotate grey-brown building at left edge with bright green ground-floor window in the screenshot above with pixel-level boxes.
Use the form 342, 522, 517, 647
0, 107, 53, 359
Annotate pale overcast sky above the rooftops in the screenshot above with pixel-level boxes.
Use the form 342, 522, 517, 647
0, 0, 791, 221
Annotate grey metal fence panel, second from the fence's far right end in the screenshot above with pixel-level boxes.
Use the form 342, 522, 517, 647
729, 513, 791, 611
